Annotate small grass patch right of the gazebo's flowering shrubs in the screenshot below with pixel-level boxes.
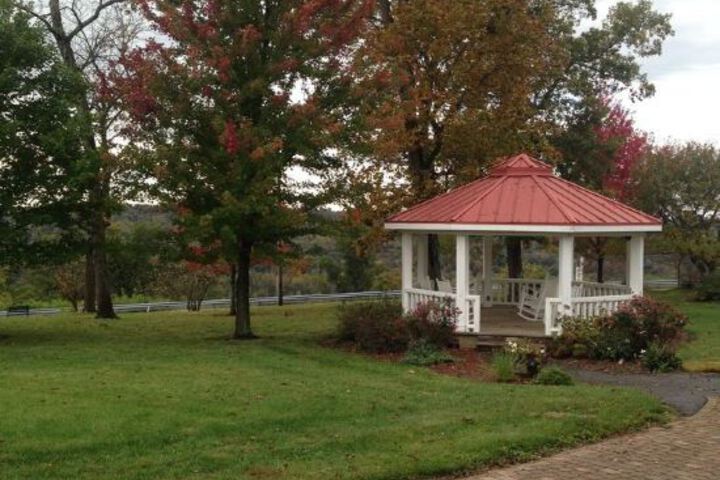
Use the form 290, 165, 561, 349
650, 290, 720, 372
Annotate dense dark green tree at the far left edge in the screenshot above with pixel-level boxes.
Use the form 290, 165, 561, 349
0, 0, 87, 265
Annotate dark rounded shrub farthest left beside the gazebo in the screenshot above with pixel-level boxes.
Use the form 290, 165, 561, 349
338, 300, 410, 353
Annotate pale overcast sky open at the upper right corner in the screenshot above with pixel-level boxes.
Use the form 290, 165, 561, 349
598, 0, 720, 144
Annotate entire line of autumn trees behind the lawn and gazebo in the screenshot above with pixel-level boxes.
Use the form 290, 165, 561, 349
0, 0, 718, 338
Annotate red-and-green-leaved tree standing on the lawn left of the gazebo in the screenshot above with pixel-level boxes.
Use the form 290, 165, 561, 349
116, 0, 372, 338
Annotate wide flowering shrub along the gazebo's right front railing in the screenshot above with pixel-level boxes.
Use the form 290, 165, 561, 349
551, 297, 687, 360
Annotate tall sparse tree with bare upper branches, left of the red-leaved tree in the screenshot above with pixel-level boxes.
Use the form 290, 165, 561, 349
16, 0, 147, 318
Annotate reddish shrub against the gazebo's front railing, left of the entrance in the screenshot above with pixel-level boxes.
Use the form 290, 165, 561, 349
405, 299, 460, 348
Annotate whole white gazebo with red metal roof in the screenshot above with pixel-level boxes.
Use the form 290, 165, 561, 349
385, 154, 662, 336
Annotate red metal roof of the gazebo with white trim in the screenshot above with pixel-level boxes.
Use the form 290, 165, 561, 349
385, 154, 662, 234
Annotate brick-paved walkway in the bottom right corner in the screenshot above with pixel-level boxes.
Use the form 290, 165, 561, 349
466, 397, 720, 480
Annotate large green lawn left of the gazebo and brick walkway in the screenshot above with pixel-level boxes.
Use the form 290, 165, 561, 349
0, 305, 667, 480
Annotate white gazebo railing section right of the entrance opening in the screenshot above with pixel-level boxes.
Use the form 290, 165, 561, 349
544, 293, 633, 335
